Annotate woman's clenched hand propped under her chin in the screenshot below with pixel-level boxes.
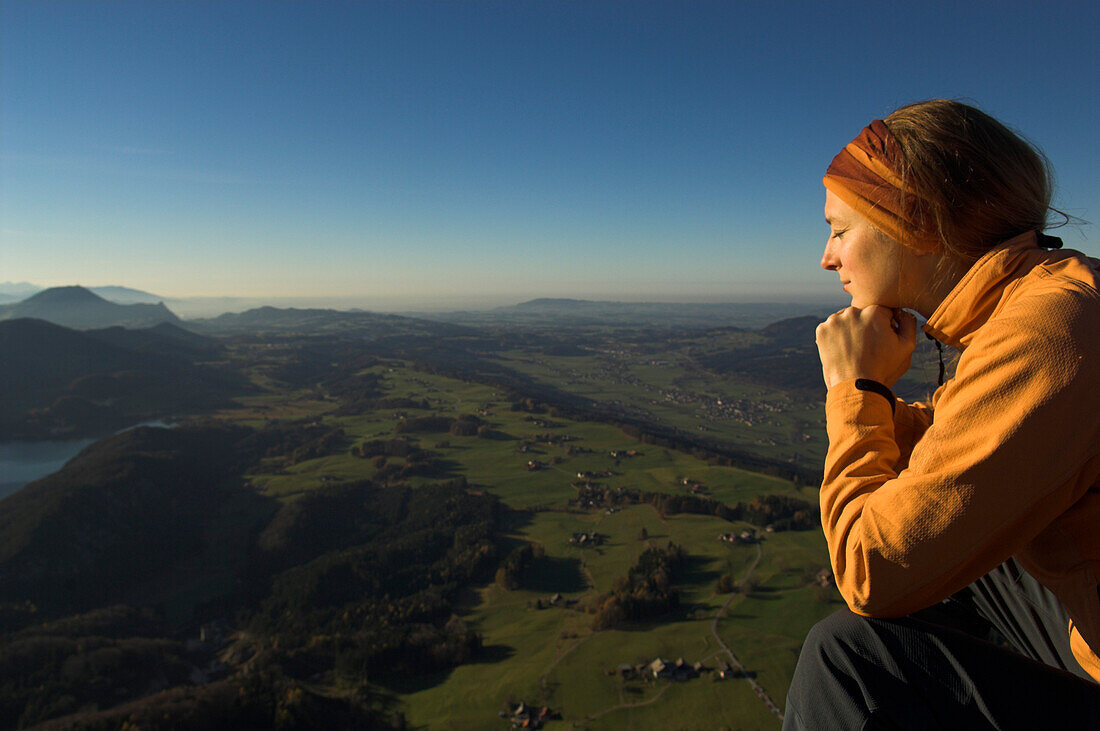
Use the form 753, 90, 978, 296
817, 304, 916, 388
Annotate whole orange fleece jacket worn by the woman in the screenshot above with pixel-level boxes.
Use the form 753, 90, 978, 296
821, 233, 1100, 680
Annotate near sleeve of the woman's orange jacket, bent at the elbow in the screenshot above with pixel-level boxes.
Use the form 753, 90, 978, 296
821, 301, 1098, 617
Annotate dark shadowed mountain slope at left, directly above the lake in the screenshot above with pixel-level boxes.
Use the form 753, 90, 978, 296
0, 319, 251, 440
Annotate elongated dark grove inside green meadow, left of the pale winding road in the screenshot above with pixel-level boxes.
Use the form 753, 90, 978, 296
592, 542, 685, 630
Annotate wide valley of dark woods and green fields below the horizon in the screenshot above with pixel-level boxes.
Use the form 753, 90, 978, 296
0, 294, 935, 729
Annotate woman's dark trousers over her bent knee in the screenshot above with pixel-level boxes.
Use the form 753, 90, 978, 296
783, 560, 1100, 730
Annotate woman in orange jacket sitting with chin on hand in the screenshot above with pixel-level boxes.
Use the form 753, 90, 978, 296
785, 100, 1100, 729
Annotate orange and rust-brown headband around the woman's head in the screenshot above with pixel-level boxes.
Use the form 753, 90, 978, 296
822, 120, 942, 252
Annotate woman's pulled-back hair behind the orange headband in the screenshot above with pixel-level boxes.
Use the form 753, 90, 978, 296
884, 99, 1064, 263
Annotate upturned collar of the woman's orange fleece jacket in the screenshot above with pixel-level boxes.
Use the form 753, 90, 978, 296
923, 231, 1046, 348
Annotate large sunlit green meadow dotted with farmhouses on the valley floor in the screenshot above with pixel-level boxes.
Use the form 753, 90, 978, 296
222, 358, 840, 729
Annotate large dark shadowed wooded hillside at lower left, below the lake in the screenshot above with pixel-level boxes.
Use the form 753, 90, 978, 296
0, 415, 502, 729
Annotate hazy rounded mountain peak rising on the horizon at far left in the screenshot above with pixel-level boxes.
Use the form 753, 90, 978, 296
0, 287, 179, 330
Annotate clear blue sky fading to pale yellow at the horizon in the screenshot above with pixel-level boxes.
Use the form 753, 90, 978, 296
0, 0, 1100, 306
